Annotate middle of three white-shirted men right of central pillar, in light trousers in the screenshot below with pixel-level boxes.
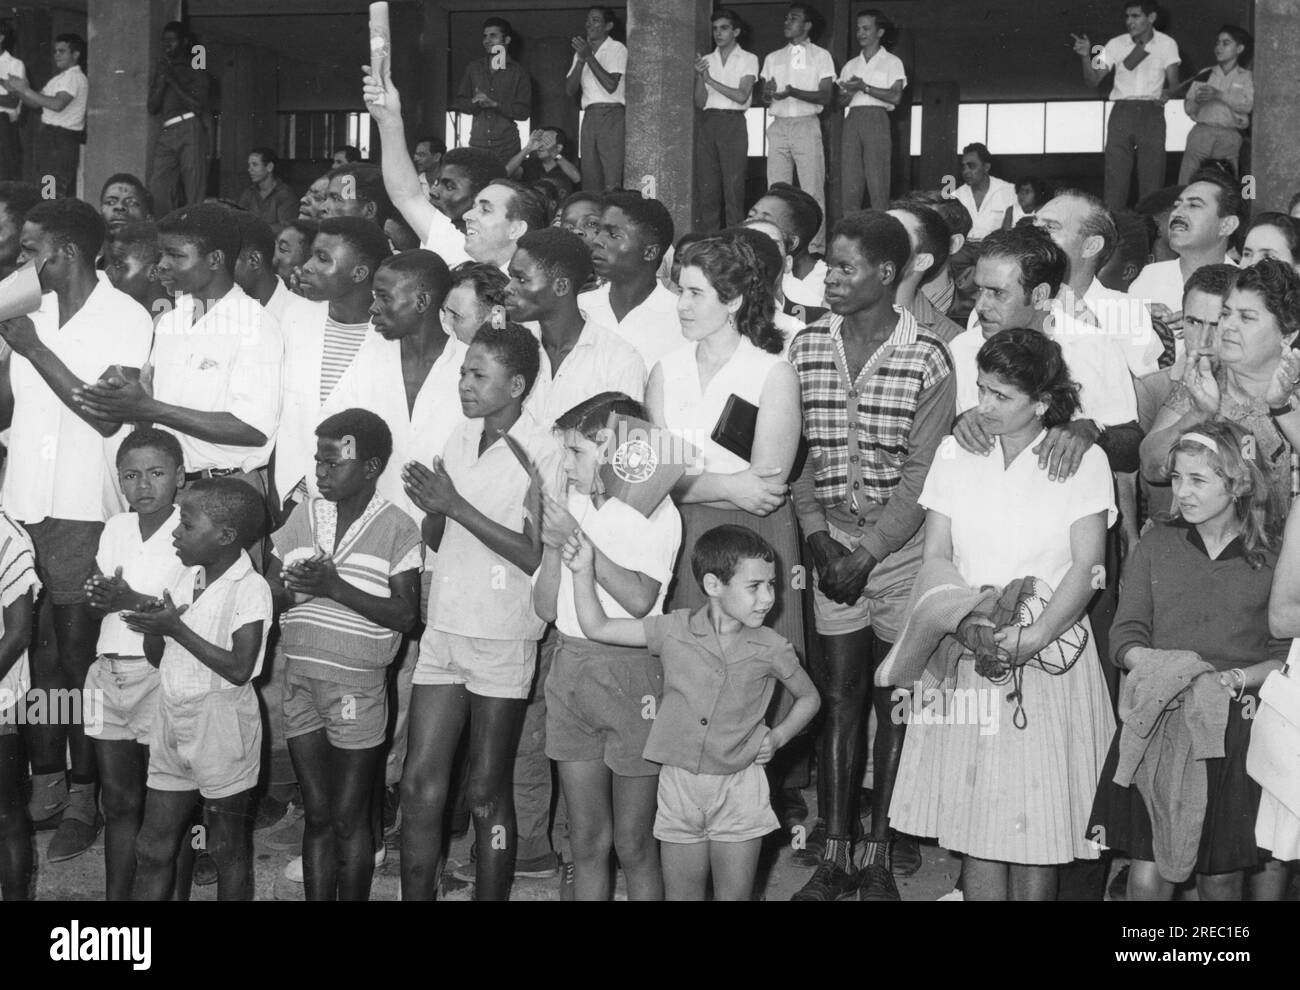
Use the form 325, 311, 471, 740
762, 4, 835, 253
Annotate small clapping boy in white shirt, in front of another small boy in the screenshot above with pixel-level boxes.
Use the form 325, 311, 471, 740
122, 478, 273, 900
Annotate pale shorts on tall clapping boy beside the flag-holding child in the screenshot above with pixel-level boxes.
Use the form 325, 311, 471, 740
411, 629, 537, 700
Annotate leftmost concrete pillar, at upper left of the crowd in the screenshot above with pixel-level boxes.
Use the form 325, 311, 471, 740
83, 0, 170, 203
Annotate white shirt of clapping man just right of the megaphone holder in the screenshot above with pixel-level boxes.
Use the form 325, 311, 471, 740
150, 286, 285, 472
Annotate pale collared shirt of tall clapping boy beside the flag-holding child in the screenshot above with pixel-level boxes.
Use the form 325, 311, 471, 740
421, 409, 566, 639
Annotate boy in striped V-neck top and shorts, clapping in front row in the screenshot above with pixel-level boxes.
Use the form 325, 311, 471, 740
267, 409, 424, 900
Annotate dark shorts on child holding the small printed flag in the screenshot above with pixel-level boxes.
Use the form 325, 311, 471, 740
542, 630, 663, 777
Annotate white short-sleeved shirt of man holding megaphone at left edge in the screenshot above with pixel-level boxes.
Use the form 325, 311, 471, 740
4, 278, 153, 524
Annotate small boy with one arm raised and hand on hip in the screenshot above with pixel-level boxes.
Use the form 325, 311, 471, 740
564, 525, 820, 900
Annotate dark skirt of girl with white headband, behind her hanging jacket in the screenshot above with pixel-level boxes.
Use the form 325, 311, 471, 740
1088, 692, 1263, 876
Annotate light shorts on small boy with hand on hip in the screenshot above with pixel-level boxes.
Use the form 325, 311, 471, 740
654, 763, 781, 843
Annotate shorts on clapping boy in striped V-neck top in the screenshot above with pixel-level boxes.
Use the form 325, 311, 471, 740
282, 660, 389, 750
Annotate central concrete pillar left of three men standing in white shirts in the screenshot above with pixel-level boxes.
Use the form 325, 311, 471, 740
624, 0, 712, 235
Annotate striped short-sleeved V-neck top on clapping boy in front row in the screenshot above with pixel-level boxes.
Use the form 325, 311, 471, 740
272, 495, 423, 687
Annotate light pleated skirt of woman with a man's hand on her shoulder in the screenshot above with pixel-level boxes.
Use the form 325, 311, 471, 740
889, 618, 1115, 867
